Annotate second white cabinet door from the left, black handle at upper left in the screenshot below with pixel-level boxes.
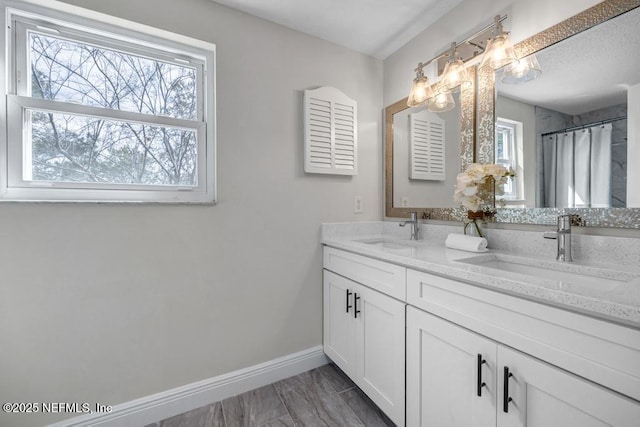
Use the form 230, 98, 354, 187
354, 286, 405, 426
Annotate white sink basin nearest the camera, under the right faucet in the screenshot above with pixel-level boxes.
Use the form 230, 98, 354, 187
458, 254, 640, 292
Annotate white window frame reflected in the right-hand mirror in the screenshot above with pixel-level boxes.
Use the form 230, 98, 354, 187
495, 117, 525, 204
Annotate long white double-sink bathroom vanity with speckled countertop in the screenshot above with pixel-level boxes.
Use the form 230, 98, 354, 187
323, 223, 640, 427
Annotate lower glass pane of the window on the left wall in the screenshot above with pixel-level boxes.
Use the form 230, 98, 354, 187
24, 111, 198, 186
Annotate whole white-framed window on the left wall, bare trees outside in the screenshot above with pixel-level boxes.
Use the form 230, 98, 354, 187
0, 5, 215, 202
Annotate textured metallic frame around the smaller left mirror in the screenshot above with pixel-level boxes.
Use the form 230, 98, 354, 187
384, 67, 476, 221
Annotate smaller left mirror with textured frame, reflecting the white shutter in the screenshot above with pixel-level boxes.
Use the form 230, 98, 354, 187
385, 67, 476, 221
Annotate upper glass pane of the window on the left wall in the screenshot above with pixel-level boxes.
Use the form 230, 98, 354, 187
29, 33, 197, 120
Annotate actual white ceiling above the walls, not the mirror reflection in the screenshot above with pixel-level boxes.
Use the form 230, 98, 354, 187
214, 0, 463, 59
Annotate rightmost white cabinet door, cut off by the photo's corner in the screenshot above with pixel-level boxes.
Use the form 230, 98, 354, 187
498, 346, 640, 427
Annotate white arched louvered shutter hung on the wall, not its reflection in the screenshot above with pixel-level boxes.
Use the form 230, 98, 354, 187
304, 86, 358, 175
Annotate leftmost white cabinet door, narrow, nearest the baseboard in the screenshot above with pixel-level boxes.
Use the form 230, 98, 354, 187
323, 270, 358, 377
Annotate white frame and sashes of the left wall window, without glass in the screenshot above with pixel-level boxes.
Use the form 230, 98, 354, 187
0, 0, 216, 203
